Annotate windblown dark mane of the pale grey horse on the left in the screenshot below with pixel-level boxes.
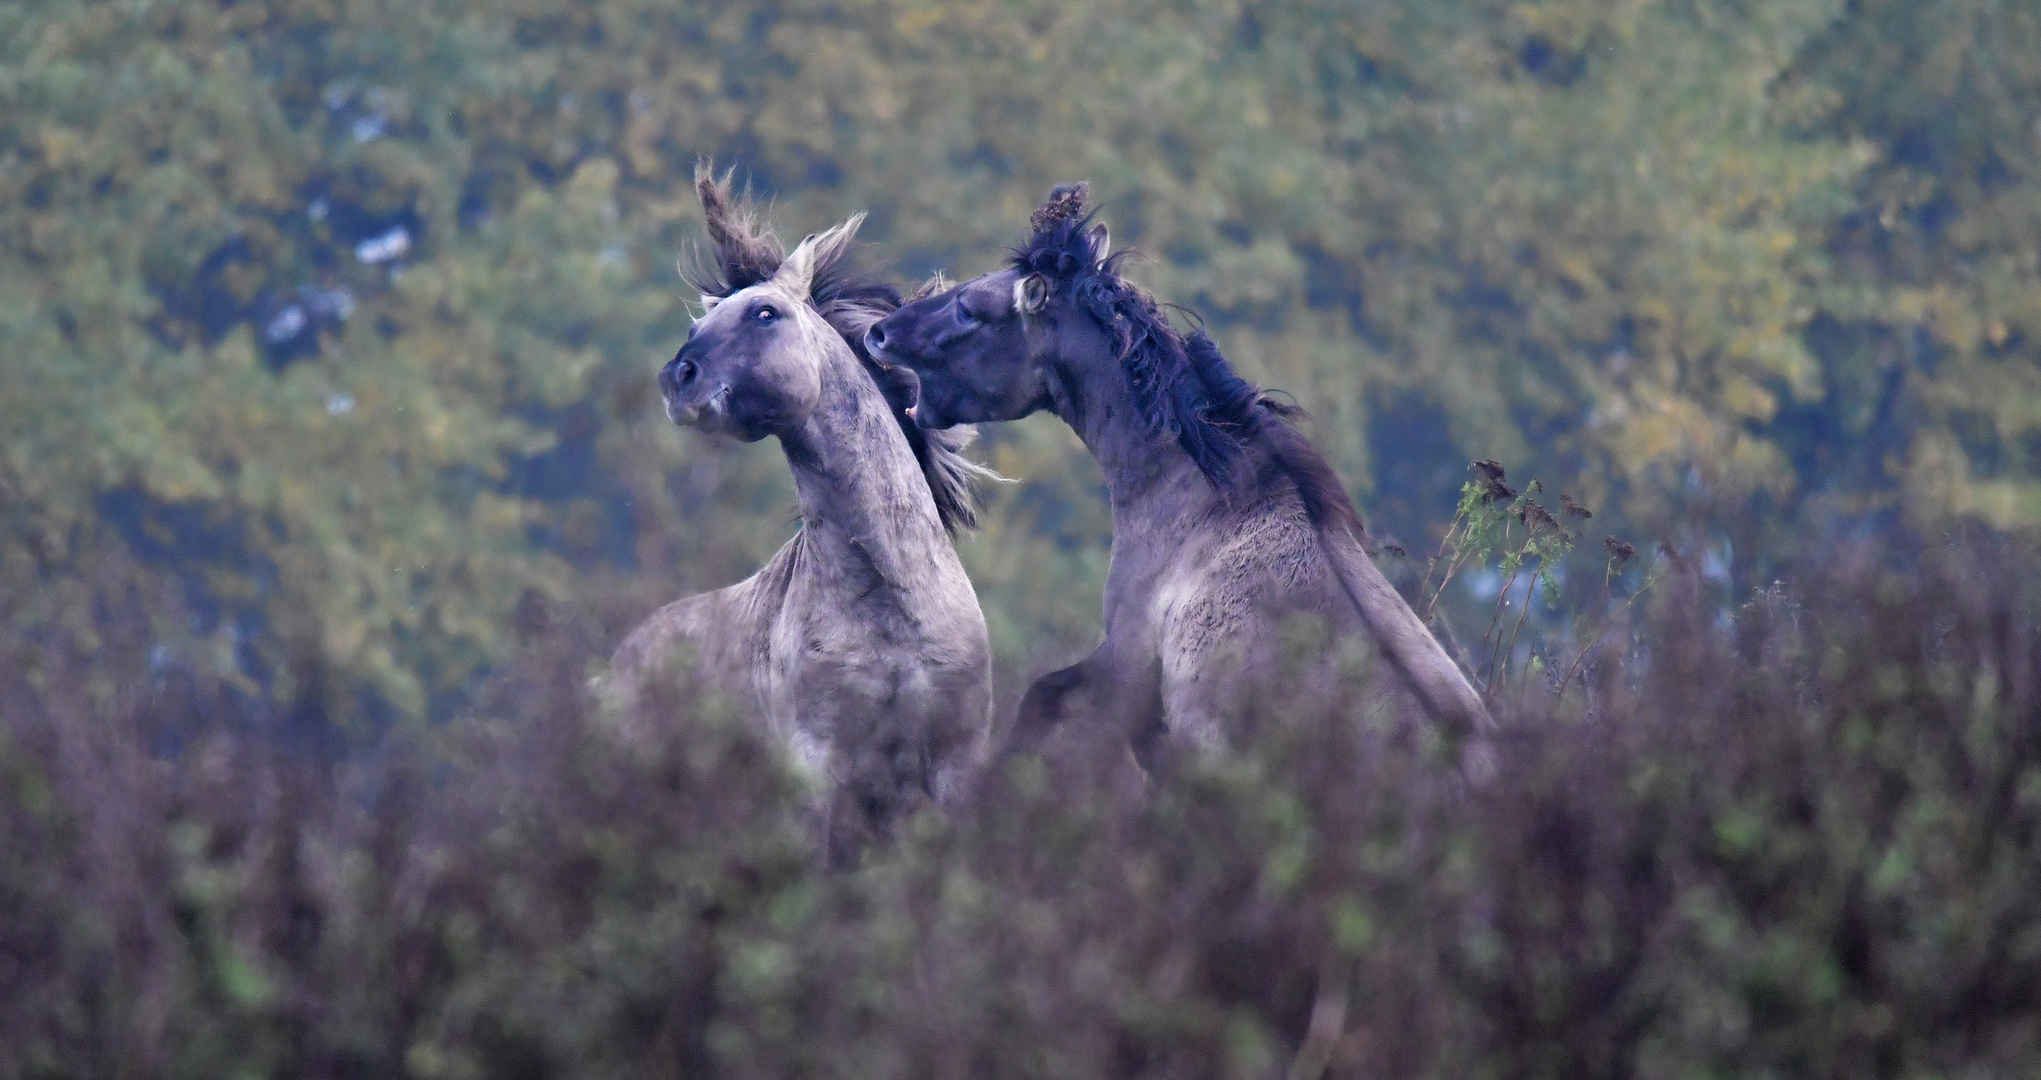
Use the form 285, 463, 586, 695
682, 161, 992, 533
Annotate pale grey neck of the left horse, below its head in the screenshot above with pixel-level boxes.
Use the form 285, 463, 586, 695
780, 349, 955, 594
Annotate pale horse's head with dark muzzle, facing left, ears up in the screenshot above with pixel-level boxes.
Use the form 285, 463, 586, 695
659, 214, 863, 443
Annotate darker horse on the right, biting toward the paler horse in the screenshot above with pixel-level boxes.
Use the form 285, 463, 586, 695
865, 184, 1488, 762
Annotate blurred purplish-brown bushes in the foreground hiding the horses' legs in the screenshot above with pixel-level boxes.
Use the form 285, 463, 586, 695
0, 530, 2041, 1078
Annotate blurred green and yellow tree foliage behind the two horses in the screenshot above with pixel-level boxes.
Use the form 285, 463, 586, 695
0, 0, 2041, 725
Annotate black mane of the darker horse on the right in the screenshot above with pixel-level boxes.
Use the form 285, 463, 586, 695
1010, 184, 1367, 545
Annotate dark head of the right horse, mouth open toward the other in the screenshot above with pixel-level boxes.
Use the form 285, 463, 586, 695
865, 184, 1108, 427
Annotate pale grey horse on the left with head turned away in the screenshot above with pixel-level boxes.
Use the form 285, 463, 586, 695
612, 169, 992, 862
